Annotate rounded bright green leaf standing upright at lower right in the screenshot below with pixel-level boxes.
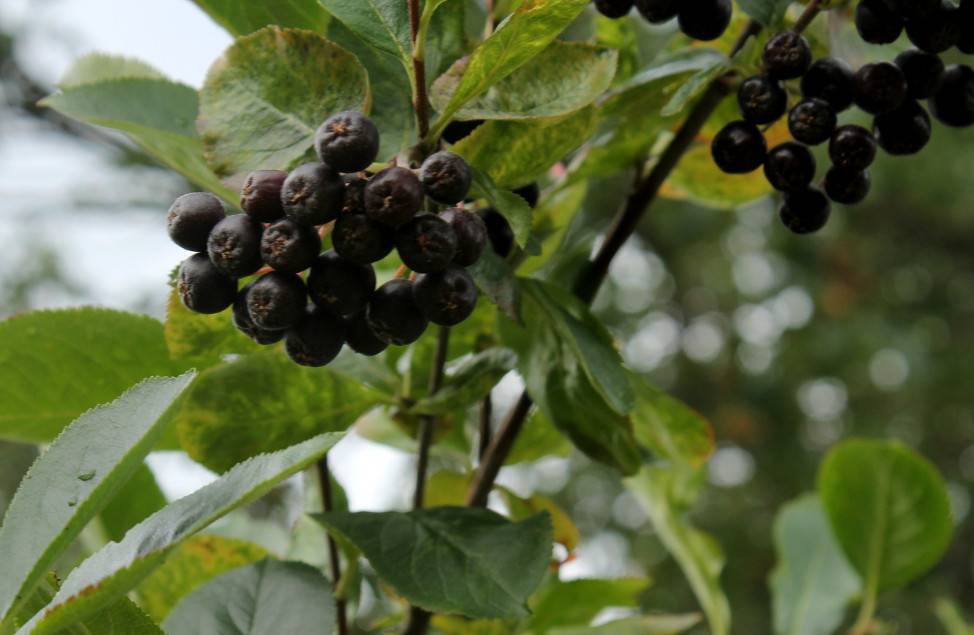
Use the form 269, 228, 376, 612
818, 440, 953, 597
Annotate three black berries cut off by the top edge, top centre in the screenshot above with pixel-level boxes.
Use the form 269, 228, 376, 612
595, 0, 734, 42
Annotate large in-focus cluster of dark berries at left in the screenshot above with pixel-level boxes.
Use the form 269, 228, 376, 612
168, 112, 488, 366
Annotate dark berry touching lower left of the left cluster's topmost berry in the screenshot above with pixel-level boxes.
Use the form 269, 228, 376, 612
281, 163, 345, 227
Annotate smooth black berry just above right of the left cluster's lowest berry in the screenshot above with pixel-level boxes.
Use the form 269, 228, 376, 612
308, 251, 375, 315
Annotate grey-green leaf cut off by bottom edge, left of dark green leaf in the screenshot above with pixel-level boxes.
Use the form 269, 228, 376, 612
164, 560, 335, 635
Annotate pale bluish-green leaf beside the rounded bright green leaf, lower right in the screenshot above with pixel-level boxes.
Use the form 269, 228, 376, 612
771, 495, 861, 635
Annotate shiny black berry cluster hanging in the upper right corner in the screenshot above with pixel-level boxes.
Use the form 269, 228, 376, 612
711, 0, 974, 234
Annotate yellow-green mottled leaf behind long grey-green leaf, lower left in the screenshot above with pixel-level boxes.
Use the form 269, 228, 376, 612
138, 535, 267, 622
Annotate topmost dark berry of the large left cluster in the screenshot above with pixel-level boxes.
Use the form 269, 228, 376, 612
315, 110, 379, 172
